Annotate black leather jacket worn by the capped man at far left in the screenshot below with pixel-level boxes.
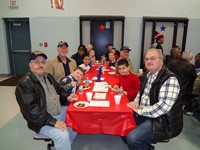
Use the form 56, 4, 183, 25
15, 71, 67, 132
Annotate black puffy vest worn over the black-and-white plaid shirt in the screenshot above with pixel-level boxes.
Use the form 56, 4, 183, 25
140, 67, 183, 142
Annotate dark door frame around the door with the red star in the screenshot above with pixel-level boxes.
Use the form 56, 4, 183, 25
79, 16, 125, 47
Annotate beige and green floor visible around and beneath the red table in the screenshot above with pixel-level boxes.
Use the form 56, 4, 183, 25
0, 77, 200, 150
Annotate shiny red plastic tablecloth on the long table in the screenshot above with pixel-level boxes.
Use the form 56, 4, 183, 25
66, 66, 136, 136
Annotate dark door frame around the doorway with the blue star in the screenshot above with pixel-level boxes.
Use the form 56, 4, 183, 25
140, 16, 189, 67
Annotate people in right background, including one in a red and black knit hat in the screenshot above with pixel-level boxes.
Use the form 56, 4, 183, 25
151, 31, 200, 115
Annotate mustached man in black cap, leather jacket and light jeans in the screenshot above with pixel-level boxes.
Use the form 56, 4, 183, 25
15, 51, 77, 150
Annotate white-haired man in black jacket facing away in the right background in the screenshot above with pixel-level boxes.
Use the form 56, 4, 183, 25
169, 50, 197, 94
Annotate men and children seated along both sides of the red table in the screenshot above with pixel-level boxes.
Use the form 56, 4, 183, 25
15, 37, 199, 150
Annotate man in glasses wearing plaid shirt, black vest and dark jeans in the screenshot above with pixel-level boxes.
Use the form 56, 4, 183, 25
127, 49, 183, 150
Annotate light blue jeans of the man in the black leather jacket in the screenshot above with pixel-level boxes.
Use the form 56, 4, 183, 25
40, 106, 77, 150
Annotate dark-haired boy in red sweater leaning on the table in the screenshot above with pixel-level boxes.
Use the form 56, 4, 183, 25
112, 59, 140, 101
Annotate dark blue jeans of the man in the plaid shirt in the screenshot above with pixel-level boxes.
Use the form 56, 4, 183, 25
126, 113, 152, 150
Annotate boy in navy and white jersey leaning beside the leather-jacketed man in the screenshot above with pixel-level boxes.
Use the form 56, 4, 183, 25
60, 67, 85, 95
